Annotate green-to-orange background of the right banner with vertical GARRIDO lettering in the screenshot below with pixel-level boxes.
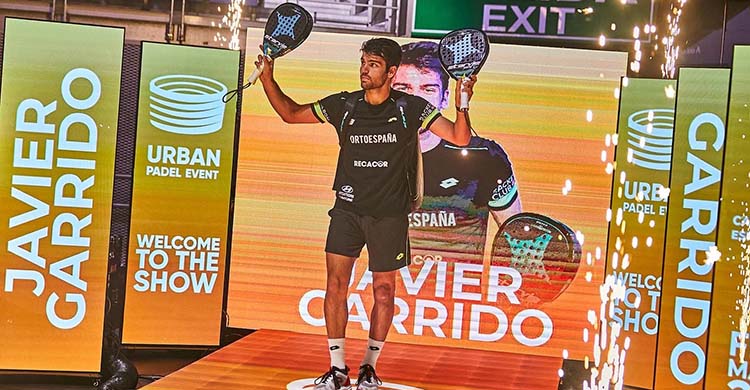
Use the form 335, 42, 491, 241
654, 68, 730, 389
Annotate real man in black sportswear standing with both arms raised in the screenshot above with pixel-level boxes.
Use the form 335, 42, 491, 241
255, 33, 476, 390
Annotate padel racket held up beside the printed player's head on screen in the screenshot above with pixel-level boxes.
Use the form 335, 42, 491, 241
438, 28, 490, 111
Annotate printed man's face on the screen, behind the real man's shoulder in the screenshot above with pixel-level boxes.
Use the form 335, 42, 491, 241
393, 65, 448, 111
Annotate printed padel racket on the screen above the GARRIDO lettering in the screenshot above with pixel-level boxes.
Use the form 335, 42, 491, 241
492, 213, 581, 305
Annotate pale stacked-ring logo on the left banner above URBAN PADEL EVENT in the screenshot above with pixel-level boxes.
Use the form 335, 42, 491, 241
149, 74, 227, 135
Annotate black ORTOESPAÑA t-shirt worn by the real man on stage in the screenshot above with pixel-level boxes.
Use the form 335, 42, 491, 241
313, 90, 440, 217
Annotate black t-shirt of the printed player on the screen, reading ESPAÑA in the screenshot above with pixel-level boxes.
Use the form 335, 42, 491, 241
409, 137, 518, 264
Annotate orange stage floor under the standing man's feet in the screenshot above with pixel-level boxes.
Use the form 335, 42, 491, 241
144, 330, 562, 390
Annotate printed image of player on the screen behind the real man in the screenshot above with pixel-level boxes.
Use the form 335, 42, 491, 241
393, 41, 521, 264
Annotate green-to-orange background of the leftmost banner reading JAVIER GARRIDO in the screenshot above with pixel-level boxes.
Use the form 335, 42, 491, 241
0, 18, 124, 372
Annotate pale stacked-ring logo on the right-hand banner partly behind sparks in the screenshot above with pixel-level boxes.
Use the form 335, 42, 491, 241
627, 109, 674, 171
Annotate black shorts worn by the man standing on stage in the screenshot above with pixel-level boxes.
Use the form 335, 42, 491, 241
326, 208, 411, 272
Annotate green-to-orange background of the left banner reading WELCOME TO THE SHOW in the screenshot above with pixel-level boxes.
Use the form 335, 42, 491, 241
123, 42, 240, 345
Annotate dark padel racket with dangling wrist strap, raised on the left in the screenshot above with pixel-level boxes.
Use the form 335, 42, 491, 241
222, 3, 313, 103
